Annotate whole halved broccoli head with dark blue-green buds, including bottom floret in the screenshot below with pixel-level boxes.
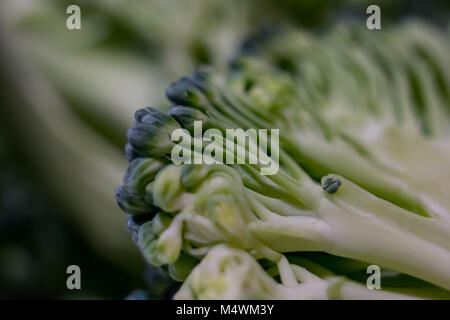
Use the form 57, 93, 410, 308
116, 21, 450, 298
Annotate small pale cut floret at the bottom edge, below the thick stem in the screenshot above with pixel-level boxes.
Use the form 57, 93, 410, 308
175, 245, 415, 300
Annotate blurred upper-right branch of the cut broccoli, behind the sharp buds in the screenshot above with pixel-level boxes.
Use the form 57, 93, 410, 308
234, 25, 450, 219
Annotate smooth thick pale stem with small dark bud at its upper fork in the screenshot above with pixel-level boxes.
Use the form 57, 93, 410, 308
249, 177, 450, 289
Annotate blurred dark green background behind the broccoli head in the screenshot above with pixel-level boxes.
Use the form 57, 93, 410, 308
0, 0, 450, 299
